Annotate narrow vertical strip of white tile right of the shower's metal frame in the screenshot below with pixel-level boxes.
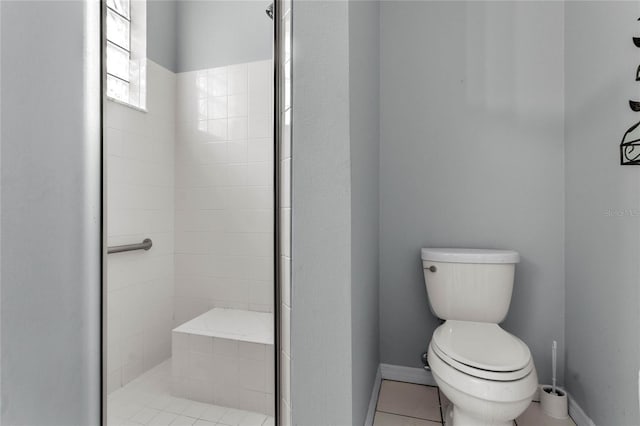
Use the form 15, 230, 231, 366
278, 0, 292, 426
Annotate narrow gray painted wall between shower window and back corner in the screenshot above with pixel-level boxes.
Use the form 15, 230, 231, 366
147, 0, 178, 72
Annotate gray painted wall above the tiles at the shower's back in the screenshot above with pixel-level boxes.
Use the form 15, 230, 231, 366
175, 0, 273, 72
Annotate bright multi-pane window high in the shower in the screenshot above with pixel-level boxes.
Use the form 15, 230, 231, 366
106, 0, 146, 109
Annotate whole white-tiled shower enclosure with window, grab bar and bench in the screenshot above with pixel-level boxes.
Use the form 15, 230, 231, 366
102, 0, 290, 425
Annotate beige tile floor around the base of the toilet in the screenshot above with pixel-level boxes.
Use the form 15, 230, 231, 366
373, 380, 576, 426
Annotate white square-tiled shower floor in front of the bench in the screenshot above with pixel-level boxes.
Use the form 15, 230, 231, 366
107, 359, 275, 426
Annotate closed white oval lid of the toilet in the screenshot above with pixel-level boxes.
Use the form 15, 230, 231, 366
432, 320, 531, 372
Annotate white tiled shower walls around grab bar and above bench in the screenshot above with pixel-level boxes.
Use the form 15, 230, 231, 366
105, 60, 273, 391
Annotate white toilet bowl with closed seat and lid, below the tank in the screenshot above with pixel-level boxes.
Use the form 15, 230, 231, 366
427, 321, 538, 426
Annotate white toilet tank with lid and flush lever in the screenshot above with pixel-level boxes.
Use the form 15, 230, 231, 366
422, 248, 520, 324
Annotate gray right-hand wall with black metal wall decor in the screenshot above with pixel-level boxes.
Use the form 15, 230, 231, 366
565, 2, 640, 425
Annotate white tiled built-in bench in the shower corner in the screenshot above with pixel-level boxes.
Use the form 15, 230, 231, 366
171, 308, 275, 416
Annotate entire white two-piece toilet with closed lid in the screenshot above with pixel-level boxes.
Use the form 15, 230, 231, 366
422, 248, 538, 426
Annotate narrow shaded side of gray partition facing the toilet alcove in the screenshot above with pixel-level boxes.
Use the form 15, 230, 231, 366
349, 1, 380, 425
